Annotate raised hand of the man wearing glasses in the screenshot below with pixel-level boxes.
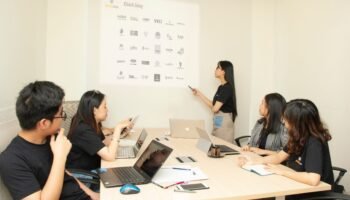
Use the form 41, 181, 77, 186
50, 128, 72, 159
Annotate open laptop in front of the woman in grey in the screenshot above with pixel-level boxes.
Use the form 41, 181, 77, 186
197, 128, 239, 155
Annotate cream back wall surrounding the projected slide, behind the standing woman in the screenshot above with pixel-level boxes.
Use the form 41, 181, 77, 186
47, 0, 251, 134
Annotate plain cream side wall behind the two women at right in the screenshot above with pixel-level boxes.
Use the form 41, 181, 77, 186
250, 0, 350, 190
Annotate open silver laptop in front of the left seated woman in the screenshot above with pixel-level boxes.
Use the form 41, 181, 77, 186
116, 129, 147, 158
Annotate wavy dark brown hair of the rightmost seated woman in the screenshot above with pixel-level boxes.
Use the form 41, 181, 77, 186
283, 99, 332, 154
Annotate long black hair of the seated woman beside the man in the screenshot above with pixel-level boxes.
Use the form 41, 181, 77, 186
67, 90, 105, 138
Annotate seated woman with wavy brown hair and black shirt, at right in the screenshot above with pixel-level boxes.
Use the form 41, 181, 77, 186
238, 99, 334, 199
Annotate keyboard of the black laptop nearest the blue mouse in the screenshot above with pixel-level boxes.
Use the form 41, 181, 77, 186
113, 167, 145, 183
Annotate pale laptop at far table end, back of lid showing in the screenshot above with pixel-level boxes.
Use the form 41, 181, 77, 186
169, 119, 204, 139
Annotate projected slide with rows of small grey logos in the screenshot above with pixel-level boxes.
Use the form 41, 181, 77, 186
99, 0, 199, 87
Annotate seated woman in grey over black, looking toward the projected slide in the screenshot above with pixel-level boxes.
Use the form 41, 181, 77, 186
242, 93, 288, 155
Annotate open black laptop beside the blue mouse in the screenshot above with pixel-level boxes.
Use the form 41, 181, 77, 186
99, 140, 173, 188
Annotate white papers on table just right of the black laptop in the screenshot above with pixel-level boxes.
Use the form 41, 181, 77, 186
152, 165, 208, 187
